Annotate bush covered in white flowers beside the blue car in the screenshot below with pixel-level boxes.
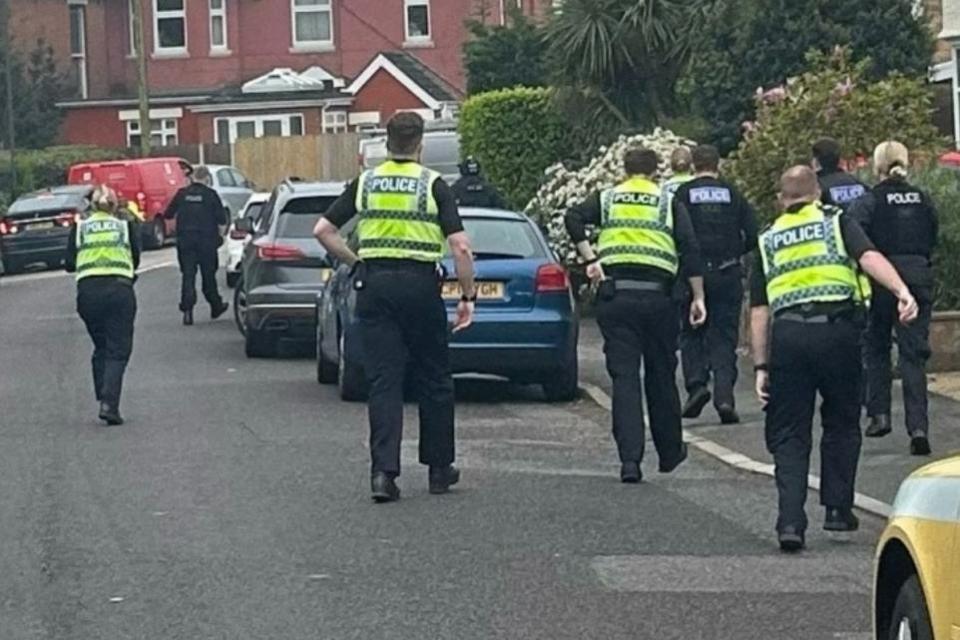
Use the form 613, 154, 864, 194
524, 128, 696, 265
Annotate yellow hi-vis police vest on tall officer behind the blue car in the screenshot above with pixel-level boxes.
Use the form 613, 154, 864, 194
356, 160, 444, 262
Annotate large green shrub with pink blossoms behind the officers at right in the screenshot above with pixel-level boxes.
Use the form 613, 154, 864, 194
728, 50, 945, 217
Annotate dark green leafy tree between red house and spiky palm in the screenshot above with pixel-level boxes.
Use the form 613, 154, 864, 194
463, 7, 547, 95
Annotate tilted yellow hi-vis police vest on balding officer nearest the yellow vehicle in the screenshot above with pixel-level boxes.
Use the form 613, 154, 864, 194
760, 203, 869, 313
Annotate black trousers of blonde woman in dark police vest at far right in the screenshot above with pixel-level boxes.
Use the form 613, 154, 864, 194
864, 287, 933, 434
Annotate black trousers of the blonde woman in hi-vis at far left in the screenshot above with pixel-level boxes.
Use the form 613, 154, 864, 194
77, 277, 137, 408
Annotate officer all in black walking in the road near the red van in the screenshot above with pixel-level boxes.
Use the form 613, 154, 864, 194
164, 167, 230, 326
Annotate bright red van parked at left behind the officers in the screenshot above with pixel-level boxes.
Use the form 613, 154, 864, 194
67, 158, 190, 249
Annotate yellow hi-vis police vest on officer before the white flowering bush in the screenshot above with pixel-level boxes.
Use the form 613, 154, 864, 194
597, 177, 680, 275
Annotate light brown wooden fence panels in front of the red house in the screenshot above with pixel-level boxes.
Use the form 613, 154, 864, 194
233, 133, 360, 188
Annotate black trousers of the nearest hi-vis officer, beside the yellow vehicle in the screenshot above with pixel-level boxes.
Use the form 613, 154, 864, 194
766, 320, 862, 530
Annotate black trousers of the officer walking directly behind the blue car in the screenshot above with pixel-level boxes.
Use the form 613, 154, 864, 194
357, 261, 454, 477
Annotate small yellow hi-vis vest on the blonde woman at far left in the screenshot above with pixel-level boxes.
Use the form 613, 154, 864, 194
77, 211, 134, 281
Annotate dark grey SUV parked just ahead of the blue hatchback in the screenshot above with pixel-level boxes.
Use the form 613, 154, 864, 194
234, 180, 344, 358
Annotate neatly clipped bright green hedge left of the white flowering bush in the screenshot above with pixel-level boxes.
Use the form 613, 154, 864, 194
460, 87, 571, 207
